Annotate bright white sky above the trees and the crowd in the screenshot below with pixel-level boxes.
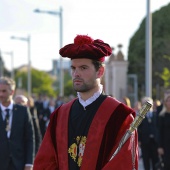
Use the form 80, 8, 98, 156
0, 0, 170, 70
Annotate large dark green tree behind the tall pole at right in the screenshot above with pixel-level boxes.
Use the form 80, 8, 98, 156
128, 4, 170, 97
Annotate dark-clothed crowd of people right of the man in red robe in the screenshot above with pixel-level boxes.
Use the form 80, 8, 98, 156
122, 90, 170, 170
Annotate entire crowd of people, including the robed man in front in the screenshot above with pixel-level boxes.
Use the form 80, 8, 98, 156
0, 35, 170, 170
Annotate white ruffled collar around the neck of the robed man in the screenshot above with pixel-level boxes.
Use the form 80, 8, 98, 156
77, 84, 103, 107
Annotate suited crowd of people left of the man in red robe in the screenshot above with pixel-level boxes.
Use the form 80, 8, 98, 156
0, 77, 72, 170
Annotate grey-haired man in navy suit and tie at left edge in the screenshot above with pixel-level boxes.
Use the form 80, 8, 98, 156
0, 77, 35, 170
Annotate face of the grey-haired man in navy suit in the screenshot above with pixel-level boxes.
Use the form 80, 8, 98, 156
0, 84, 14, 105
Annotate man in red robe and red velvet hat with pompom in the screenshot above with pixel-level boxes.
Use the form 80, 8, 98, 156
33, 35, 138, 170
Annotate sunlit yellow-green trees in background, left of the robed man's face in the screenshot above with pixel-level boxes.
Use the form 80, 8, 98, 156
5, 65, 75, 97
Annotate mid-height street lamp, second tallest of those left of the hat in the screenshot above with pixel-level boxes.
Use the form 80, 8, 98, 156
11, 36, 31, 96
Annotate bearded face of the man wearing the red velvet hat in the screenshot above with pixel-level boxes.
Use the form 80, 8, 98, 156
71, 58, 99, 92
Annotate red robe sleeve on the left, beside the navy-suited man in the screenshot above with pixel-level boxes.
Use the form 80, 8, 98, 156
33, 110, 59, 170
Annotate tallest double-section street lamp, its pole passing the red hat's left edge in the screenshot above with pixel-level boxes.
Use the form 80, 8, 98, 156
34, 7, 64, 96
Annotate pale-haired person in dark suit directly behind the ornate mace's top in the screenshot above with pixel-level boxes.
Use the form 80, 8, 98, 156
138, 97, 158, 170
